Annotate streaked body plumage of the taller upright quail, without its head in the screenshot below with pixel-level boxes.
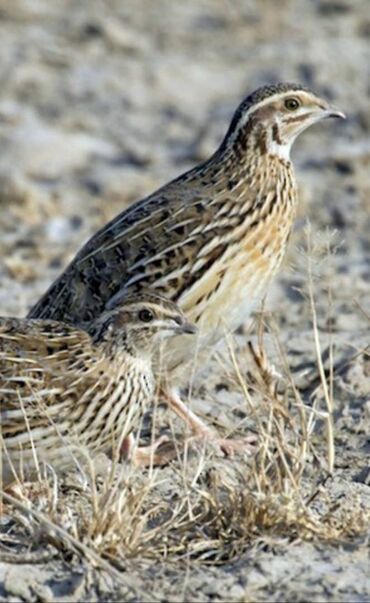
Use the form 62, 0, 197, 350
27, 154, 296, 372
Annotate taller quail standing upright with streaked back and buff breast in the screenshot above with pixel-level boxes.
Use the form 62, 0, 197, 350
30, 84, 344, 451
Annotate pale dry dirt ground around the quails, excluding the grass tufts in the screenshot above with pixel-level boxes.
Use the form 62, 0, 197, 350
0, 0, 370, 602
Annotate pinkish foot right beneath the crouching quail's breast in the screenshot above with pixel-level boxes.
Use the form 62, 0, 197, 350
120, 433, 177, 467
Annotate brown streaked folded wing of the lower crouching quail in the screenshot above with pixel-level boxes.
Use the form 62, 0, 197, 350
0, 318, 96, 437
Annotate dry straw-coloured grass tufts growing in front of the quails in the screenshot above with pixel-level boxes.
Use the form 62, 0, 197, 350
3, 224, 370, 572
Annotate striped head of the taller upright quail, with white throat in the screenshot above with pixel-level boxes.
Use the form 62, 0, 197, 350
223, 84, 345, 160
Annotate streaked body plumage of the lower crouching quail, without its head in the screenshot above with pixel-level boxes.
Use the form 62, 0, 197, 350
0, 318, 154, 483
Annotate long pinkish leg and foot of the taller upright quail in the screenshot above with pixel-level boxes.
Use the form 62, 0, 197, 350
161, 389, 257, 456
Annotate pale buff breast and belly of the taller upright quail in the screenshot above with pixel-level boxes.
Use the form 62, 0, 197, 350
160, 172, 295, 378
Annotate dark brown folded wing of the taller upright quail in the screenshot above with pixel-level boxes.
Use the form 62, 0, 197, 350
29, 167, 240, 325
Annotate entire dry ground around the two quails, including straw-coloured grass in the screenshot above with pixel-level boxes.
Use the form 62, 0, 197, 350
0, 0, 370, 602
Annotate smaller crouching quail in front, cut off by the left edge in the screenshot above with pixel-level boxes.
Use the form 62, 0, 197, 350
0, 292, 195, 484
